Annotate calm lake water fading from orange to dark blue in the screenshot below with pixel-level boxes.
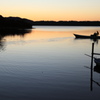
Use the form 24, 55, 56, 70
0, 26, 100, 100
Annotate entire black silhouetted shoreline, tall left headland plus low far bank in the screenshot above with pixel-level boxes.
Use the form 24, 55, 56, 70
0, 15, 100, 28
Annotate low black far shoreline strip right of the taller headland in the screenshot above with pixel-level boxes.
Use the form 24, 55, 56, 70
33, 21, 100, 26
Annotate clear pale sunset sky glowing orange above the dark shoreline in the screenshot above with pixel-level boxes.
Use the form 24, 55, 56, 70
0, 0, 100, 21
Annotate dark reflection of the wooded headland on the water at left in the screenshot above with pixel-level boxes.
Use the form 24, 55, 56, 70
0, 28, 31, 51
